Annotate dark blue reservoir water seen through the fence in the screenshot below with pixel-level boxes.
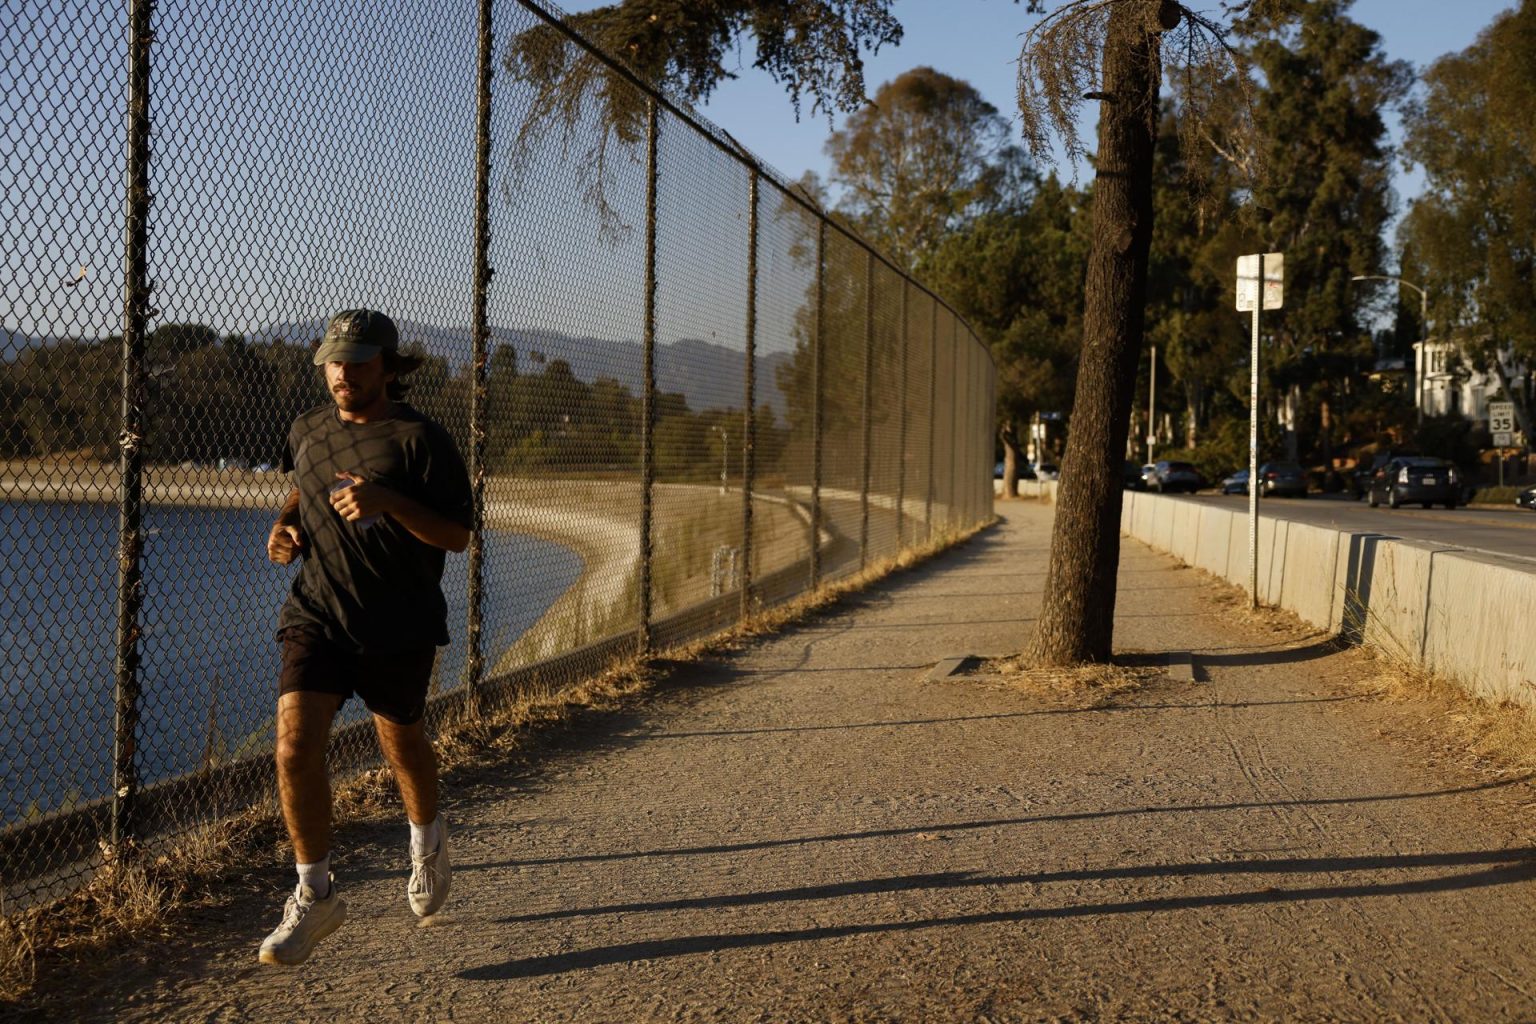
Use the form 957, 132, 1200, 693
0, 502, 582, 823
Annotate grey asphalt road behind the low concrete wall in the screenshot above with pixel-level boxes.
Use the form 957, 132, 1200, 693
1178, 494, 1536, 562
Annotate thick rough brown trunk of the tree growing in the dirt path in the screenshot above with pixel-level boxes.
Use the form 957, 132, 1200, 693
1031, 2, 1161, 665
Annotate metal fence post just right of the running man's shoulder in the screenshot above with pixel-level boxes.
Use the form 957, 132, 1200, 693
464, 0, 492, 712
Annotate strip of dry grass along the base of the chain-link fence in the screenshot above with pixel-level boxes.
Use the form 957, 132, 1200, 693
0, 524, 991, 1009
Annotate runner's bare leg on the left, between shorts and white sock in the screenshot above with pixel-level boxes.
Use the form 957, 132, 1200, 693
276, 691, 341, 864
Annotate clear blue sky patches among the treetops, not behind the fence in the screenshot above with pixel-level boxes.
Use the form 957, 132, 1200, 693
562, 0, 1513, 218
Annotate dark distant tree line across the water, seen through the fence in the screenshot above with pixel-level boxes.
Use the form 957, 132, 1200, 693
0, 324, 808, 479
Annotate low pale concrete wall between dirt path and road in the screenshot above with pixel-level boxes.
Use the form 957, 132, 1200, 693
1118, 497, 1536, 708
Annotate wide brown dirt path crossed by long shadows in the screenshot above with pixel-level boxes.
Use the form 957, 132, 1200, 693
51, 502, 1536, 1022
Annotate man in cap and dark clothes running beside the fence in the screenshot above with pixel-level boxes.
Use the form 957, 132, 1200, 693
261, 310, 473, 964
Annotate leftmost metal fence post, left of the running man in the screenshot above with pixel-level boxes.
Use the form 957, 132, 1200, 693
112, 0, 155, 855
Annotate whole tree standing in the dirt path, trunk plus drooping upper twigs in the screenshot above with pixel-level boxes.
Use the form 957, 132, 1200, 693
1018, 0, 1260, 665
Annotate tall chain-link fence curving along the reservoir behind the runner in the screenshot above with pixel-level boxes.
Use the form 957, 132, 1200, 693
0, 0, 995, 906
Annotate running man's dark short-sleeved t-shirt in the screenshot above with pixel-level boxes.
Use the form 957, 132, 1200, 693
278, 402, 473, 654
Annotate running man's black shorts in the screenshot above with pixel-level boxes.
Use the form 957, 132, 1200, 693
278, 626, 438, 725
